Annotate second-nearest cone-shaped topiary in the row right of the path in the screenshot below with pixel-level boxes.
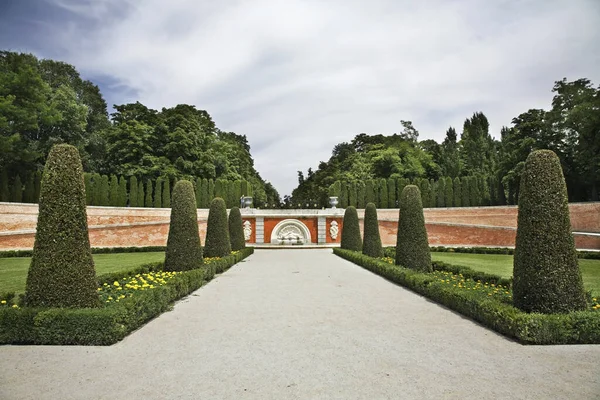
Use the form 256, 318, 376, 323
396, 185, 433, 272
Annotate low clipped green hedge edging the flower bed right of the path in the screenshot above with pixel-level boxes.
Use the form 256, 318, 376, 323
333, 248, 600, 345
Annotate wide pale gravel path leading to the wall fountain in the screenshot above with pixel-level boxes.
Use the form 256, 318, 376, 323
0, 250, 600, 400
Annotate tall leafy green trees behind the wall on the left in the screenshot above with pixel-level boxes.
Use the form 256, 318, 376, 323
0, 51, 279, 207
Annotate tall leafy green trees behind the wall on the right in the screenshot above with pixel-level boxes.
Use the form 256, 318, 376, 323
285, 79, 600, 208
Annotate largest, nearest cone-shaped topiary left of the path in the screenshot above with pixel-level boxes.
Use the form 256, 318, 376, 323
25, 144, 100, 307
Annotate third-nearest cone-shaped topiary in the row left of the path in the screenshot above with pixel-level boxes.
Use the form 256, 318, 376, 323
204, 197, 231, 257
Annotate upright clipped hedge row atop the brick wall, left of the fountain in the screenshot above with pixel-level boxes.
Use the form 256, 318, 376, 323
0, 172, 253, 208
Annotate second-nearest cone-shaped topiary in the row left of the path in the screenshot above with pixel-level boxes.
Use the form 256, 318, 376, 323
165, 180, 202, 271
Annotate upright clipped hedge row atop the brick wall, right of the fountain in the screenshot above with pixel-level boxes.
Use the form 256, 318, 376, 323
329, 176, 504, 208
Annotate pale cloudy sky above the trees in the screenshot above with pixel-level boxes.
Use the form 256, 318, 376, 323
0, 0, 600, 195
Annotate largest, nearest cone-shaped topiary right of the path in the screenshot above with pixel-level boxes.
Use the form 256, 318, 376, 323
513, 150, 587, 314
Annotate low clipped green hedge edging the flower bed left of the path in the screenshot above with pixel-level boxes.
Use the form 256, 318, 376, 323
0, 247, 254, 346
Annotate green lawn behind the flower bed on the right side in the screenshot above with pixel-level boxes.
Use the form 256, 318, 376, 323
431, 253, 600, 295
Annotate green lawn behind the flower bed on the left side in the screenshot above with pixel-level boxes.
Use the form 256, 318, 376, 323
0, 252, 165, 293
